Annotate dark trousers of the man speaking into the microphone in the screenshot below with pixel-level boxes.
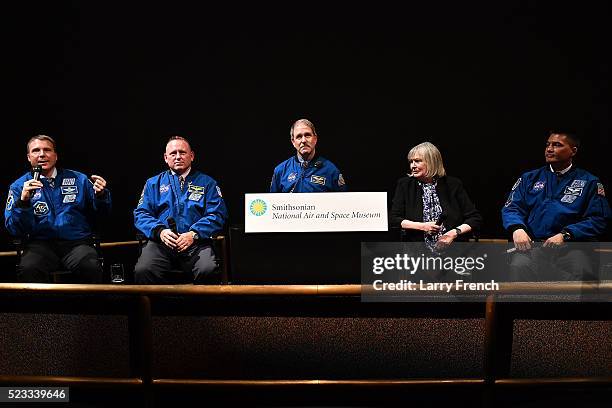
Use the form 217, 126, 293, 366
17, 239, 103, 283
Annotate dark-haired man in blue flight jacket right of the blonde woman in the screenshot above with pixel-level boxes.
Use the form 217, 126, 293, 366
502, 131, 610, 281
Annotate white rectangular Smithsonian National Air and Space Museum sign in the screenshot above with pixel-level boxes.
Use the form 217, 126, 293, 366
244, 192, 389, 233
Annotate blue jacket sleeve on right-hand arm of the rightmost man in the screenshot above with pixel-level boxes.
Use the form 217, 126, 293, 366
565, 179, 611, 241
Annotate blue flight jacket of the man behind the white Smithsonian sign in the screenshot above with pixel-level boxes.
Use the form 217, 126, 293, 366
270, 155, 346, 193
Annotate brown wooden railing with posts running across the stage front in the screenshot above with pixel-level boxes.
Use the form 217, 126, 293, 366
0, 283, 612, 400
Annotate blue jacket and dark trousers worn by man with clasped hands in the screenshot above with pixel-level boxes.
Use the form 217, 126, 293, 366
134, 169, 228, 284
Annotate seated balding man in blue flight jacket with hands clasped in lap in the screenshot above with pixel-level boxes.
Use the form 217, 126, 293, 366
134, 136, 227, 284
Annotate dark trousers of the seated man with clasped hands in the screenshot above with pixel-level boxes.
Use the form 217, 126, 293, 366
134, 241, 221, 285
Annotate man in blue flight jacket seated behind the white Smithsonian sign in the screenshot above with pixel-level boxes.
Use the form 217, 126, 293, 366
270, 119, 346, 193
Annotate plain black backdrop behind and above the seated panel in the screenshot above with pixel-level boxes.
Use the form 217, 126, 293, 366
0, 1, 612, 249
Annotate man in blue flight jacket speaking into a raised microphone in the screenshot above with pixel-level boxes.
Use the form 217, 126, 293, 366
4, 135, 111, 283
